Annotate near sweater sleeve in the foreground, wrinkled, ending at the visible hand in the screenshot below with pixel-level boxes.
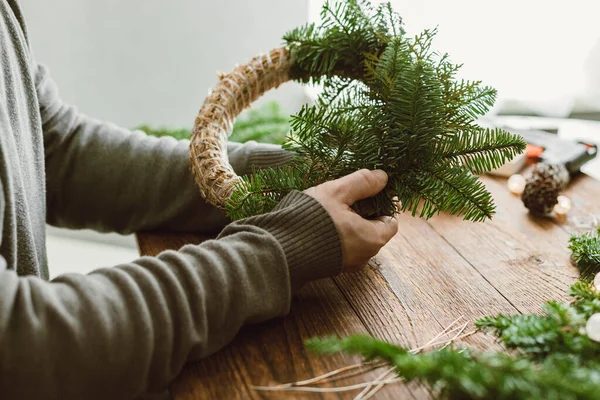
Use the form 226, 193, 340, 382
0, 192, 342, 400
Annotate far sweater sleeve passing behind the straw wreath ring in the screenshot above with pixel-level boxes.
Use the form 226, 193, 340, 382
36, 66, 292, 234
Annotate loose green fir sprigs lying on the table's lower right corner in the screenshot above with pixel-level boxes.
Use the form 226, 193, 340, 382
296, 227, 600, 400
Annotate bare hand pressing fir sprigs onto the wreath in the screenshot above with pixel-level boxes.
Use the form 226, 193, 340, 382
304, 169, 398, 272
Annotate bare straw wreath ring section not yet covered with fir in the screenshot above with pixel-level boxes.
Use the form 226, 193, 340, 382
190, 48, 291, 208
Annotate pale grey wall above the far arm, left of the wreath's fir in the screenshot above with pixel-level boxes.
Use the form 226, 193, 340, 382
22, 0, 309, 127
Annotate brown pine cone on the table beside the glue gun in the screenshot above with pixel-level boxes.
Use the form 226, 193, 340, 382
521, 164, 570, 215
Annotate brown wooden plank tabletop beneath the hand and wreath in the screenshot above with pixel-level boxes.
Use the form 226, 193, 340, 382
138, 175, 600, 400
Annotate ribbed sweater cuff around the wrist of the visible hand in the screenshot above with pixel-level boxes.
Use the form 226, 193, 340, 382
244, 191, 342, 292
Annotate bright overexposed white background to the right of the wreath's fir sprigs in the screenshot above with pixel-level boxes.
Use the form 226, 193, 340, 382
382, 0, 600, 117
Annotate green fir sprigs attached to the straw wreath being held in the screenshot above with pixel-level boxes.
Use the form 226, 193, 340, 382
227, 0, 525, 221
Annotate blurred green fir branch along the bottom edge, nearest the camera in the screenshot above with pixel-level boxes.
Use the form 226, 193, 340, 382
307, 336, 600, 400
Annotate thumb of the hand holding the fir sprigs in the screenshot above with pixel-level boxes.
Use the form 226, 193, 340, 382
335, 169, 388, 205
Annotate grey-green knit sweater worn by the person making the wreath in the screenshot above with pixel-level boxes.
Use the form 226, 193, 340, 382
0, 0, 342, 400
